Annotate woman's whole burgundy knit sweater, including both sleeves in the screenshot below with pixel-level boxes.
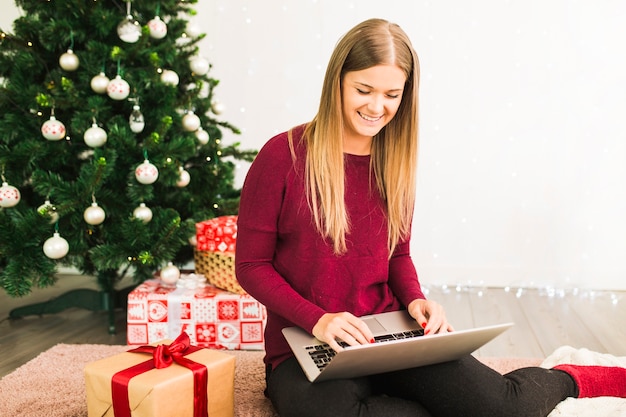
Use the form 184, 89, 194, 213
235, 126, 425, 368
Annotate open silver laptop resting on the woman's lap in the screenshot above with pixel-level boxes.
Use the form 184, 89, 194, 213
283, 310, 513, 382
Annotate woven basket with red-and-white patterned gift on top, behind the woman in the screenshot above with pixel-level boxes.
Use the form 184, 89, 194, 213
194, 216, 245, 294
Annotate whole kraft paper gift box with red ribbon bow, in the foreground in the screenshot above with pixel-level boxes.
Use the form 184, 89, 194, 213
84, 334, 235, 417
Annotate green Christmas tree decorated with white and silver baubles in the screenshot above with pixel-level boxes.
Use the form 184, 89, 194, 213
0, 0, 255, 324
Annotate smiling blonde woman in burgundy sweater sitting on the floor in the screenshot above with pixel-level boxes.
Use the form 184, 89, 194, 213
236, 19, 626, 417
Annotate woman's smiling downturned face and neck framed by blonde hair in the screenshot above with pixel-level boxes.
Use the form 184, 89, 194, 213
341, 65, 406, 155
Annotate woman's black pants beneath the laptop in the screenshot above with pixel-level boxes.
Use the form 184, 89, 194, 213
267, 356, 578, 417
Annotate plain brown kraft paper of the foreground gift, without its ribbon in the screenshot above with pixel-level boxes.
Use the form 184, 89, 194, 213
85, 334, 235, 417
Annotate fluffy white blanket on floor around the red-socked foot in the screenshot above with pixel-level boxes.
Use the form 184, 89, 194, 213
541, 346, 626, 417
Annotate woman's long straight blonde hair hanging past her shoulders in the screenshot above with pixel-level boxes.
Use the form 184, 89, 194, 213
290, 19, 419, 256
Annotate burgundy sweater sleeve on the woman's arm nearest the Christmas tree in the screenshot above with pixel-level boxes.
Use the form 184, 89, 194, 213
235, 134, 325, 332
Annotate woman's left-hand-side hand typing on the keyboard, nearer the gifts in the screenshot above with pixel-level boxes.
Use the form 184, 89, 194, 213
313, 312, 374, 352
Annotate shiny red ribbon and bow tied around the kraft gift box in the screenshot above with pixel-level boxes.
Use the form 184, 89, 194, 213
111, 332, 209, 417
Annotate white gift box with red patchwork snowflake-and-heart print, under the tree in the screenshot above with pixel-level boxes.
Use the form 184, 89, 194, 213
127, 274, 267, 350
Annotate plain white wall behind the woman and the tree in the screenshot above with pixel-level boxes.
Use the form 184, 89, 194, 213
0, 0, 626, 289
